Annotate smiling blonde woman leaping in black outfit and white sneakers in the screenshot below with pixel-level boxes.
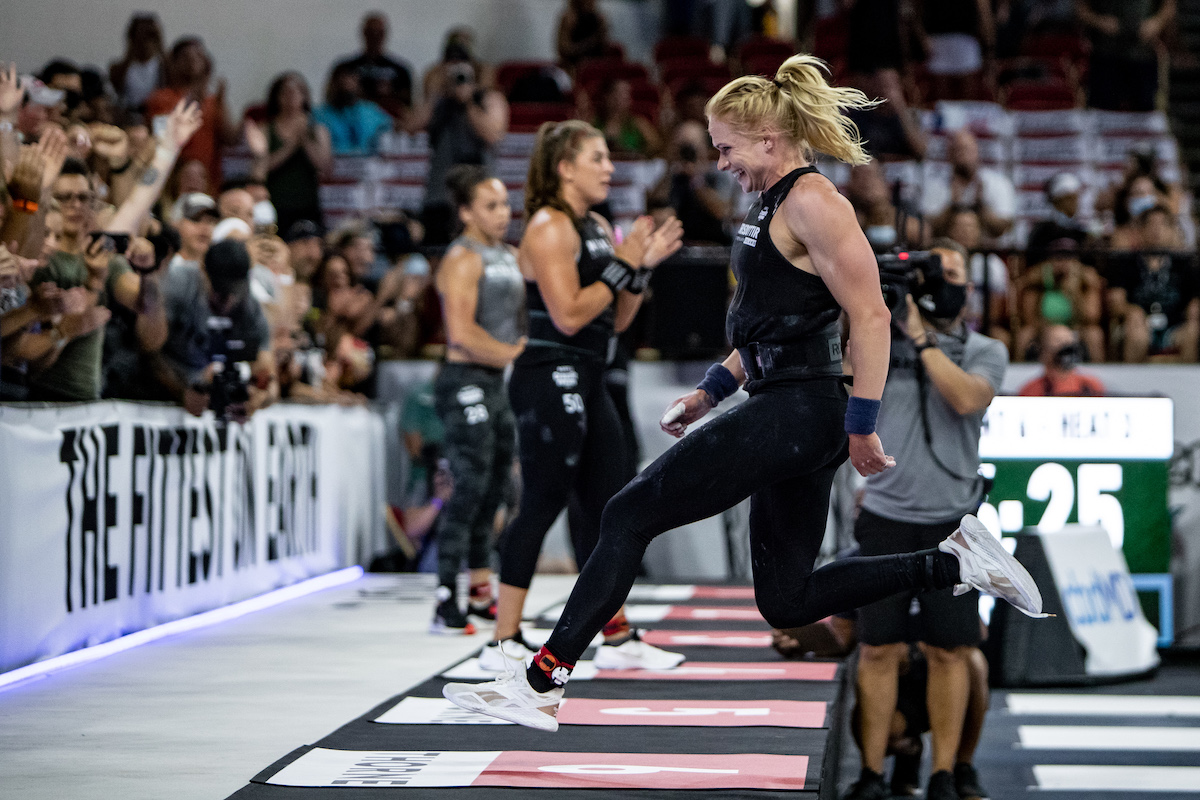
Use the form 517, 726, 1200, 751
444, 55, 1042, 730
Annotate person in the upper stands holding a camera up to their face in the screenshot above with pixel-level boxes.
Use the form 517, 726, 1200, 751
413, 61, 509, 245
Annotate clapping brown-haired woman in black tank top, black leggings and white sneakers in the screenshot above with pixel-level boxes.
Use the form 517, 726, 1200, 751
480, 120, 683, 670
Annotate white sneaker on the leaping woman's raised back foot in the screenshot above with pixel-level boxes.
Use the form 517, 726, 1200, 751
937, 515, 1050, 618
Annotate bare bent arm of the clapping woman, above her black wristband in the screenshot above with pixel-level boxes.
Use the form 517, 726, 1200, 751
520, 209, 629, 336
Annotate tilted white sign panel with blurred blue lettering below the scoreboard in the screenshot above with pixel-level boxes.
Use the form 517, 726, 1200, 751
1038, 525, 1159, 676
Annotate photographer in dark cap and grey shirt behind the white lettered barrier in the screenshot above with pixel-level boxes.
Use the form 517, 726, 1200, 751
157, 239, 278, 422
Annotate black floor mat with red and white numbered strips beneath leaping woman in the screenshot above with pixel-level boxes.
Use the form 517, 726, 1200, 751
223, 585, 847, 800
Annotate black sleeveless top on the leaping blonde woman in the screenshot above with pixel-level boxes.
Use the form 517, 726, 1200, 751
725, 167, 841, 349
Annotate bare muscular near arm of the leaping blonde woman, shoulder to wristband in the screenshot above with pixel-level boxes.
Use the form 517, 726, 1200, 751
781, 179, 892, 399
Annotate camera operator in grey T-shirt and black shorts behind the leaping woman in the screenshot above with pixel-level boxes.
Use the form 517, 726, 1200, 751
850, 239, 1008, 800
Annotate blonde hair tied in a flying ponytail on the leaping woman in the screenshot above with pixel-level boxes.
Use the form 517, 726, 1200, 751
704, 55, 882, 164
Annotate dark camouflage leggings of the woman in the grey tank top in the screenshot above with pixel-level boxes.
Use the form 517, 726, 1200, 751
433, 363, 516, 591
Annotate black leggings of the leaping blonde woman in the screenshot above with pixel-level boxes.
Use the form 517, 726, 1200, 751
546, 379, 950, 663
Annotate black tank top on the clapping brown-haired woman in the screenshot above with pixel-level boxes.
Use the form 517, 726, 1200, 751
518, 213, 617, 362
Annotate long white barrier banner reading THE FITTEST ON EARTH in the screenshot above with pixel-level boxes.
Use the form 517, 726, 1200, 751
0, 402, 383, 672
